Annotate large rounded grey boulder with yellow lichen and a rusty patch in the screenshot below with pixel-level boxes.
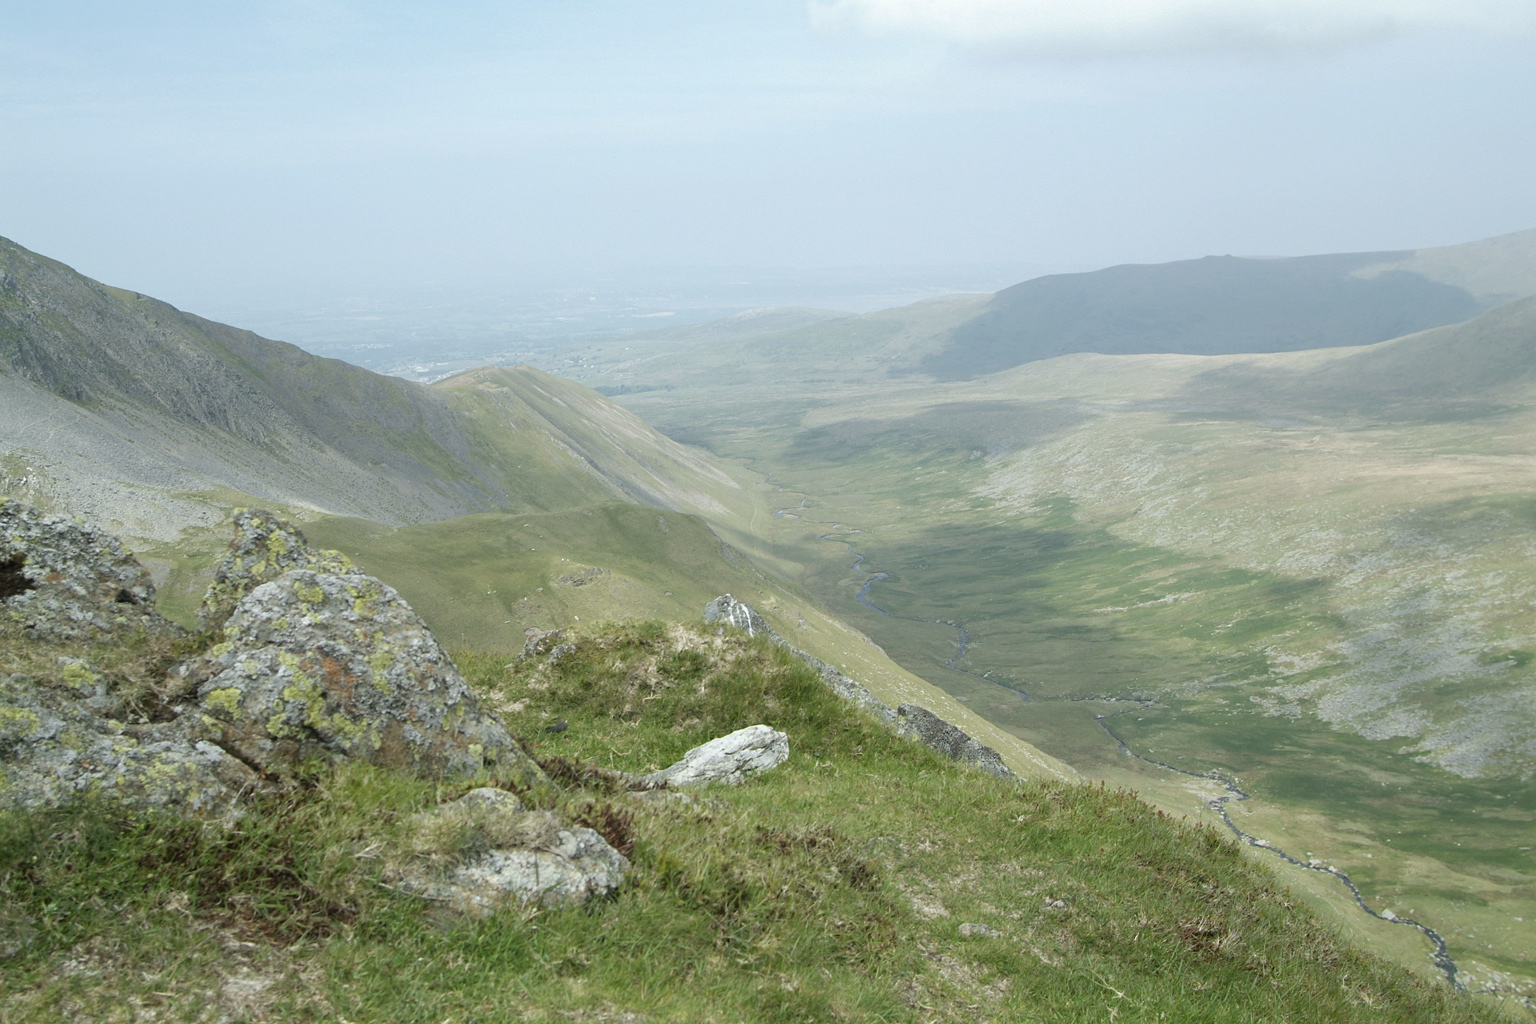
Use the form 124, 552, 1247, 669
198, 570, 542, 781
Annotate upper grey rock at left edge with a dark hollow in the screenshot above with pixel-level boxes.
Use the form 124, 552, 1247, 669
0, 500, 180, 640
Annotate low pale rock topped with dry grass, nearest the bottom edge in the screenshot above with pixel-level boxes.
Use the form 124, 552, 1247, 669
390, 789, 630, 909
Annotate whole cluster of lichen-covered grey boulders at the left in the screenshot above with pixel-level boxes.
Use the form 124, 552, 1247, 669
0, 502, 545, 815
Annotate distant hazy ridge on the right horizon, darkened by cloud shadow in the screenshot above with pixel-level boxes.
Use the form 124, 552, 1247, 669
558, 230, 1536, 393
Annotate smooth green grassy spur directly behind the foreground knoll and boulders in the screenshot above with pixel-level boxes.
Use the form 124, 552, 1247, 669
296, 505, 1075, 778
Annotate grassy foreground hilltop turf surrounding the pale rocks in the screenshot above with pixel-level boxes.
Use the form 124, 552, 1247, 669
0, 622, 1501, 1024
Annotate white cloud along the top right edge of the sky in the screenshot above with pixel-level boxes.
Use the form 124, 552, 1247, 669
809, 0, 1536, 54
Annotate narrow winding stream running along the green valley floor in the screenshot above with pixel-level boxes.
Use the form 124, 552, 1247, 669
763, 476, 1464, 989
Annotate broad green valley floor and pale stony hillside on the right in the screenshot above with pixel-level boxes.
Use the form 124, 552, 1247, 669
586, 302, 1536, 995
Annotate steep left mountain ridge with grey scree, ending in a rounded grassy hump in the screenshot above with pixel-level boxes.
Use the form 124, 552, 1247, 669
0, 239, 752, 539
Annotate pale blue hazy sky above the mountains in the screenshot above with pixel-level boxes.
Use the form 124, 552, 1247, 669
0, 0, 1536, 309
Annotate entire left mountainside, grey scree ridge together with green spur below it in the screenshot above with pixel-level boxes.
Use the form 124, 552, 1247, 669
0, 243, 1071, 775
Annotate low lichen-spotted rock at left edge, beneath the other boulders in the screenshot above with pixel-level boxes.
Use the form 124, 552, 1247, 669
0, 674, 260, 815
